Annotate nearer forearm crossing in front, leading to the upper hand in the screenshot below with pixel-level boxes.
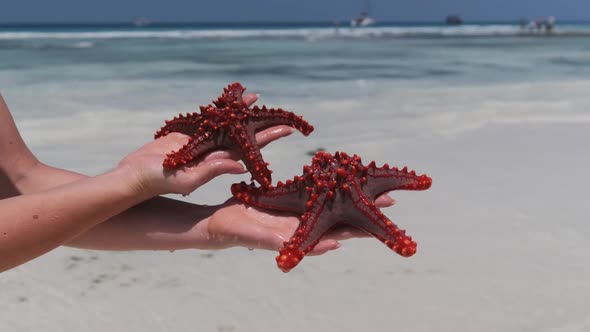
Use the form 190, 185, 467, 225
0, 170, 147, 271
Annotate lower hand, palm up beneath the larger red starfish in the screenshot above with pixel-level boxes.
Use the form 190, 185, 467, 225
206, 194, 395, 255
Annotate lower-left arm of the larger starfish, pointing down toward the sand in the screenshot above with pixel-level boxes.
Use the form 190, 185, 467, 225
276, 193, 335, 272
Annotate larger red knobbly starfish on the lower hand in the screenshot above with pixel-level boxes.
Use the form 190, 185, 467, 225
232, 152, 432, 272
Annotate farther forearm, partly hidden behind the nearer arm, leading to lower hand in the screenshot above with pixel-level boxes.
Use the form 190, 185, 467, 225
0, 95, 230, 255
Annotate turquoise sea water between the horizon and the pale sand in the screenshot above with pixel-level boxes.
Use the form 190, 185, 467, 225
0, 24, 590, 96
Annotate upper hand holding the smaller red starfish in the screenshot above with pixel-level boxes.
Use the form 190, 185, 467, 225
118, 94, 294, 199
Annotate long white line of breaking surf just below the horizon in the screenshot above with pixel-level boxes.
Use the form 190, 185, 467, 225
0, 25, 590, 40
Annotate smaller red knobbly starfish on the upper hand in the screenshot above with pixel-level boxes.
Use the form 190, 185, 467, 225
155, 82, 313, 187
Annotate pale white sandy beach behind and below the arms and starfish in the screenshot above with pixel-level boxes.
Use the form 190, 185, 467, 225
0, 80, 590, 332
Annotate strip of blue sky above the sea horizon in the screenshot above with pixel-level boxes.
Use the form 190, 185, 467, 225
0, 0, 590, 24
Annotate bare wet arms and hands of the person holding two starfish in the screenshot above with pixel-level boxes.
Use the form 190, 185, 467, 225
0, 95, 394, 272
